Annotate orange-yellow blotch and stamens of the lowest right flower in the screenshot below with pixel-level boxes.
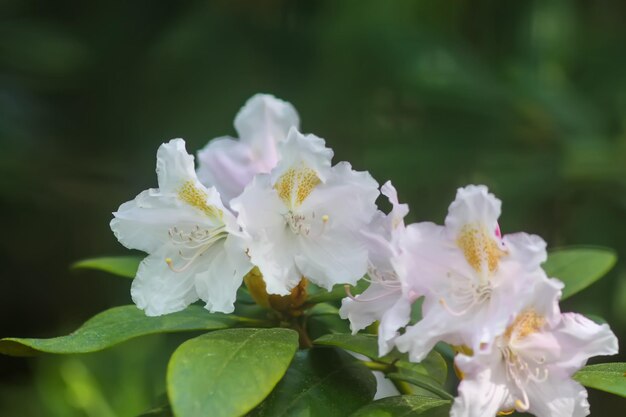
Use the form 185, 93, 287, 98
499, 310, 549, 412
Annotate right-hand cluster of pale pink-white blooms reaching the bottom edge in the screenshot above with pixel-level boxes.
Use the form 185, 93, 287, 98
341, 184, 617, 417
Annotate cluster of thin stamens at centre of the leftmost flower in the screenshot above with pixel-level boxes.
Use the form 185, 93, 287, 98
165, 225, 228, 272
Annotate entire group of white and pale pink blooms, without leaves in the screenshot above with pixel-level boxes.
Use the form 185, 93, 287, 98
111, 95, 617, 417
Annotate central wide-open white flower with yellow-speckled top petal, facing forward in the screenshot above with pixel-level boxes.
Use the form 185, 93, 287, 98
231, 128, 379, 295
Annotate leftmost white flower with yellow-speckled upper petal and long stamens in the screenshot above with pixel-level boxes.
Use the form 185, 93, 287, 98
111, 139, 252, 316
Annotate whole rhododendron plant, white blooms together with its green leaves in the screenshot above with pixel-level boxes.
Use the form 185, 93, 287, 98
0, 95, 626, 417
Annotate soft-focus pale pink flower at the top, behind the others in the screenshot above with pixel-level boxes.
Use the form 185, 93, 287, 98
198, 94, 300, 202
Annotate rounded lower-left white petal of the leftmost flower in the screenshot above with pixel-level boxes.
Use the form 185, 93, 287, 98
130, 251, 198, 316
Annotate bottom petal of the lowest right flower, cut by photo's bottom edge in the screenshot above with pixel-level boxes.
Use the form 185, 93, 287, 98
526, 377, 589, 417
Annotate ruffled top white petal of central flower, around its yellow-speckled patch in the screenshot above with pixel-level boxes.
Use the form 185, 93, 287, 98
271, 127, 333, 184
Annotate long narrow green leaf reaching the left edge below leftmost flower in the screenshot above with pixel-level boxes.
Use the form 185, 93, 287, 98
0, 305, 237, 356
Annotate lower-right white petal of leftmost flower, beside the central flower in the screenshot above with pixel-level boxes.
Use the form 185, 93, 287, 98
195, 235, 252, 313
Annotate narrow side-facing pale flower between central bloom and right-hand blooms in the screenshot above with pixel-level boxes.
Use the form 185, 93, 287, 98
339, 181, 414, 356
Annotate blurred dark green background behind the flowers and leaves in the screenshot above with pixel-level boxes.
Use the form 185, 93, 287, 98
0, 0, 626, 417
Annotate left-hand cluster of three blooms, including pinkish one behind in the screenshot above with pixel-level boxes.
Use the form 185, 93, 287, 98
111, 95, 379, 316
